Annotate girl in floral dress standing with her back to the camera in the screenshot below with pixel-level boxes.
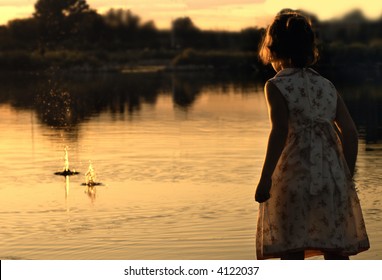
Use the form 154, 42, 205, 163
255, 10, 370, 259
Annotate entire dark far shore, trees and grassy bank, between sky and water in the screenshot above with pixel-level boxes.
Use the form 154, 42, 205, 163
0, 0, 382, 79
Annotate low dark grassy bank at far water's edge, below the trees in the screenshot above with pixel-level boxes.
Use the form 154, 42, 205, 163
0, 49, 382, 83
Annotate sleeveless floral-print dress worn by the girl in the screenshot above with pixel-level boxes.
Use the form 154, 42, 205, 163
256, 68, 370, 259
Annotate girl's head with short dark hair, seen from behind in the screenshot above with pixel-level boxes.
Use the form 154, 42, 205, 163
259, 9, 318, 67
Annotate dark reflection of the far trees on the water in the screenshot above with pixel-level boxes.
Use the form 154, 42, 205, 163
0, 73, 382, 143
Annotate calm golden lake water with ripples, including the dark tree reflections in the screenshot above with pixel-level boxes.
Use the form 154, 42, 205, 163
0, 72, 382, 259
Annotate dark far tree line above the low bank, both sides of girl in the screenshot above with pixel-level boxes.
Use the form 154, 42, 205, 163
0, 0, 382, 76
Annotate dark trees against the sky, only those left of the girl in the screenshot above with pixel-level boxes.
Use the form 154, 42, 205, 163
0, 0, 262, 53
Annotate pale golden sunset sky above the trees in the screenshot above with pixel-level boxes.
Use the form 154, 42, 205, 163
0, 0, 382, 30
